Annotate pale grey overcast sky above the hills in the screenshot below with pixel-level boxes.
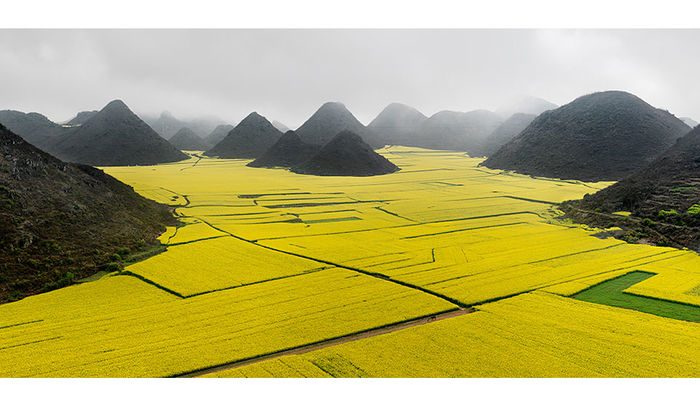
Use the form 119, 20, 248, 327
0, 30, 700, 128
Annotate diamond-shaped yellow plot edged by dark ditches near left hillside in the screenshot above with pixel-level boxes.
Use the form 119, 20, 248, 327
126, 236, 327, 297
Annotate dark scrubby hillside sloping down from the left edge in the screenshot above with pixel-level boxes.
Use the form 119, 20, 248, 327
0, 126, 175, 303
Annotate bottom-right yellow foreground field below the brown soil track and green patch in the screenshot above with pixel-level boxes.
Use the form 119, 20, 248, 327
210, 293, 700, 377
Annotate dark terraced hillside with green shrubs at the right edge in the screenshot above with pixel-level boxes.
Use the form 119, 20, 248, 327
562, 127, 700, 251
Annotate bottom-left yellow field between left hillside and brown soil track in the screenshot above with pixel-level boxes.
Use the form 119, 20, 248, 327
0, 269, 455, 377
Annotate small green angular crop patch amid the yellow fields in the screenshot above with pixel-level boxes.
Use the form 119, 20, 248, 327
573, 271, 700, 322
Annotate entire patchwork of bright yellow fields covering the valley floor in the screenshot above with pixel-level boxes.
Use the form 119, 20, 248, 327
0, 147, 700, 377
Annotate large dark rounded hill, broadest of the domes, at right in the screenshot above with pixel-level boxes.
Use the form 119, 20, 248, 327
482, 91, 690, 181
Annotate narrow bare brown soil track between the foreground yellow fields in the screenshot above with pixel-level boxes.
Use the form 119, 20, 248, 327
172, 308, 475, 377
